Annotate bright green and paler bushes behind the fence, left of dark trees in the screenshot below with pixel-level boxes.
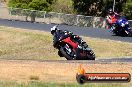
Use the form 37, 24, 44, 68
8, 0, 74, 13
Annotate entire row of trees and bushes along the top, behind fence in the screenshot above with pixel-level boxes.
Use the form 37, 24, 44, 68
8, 0, 132, 19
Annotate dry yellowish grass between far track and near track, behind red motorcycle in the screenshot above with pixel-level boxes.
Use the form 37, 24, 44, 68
0, 26, 132, 60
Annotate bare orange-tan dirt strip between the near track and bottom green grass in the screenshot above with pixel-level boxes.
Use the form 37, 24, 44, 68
0, 60, 132, 83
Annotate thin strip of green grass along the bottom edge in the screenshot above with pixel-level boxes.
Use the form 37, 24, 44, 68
0, 81, 132, 87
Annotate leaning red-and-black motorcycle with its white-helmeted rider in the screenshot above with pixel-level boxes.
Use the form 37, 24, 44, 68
51, 26, 95, 60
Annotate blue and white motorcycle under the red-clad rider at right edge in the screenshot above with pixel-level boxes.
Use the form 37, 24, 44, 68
110, 16, 132, 36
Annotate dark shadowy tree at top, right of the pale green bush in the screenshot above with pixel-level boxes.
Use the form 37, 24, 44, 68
72, 0, 104, 16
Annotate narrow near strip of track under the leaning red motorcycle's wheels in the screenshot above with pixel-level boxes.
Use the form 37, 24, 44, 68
0, 57, 132, 64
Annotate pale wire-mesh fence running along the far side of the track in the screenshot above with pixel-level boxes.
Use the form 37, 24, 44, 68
0, 7, 132, 28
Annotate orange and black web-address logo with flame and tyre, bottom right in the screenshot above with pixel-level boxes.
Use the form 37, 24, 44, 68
76, 65, 131, 84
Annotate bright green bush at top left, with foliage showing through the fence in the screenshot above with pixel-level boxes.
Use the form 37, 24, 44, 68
8, 0, 54, 22
